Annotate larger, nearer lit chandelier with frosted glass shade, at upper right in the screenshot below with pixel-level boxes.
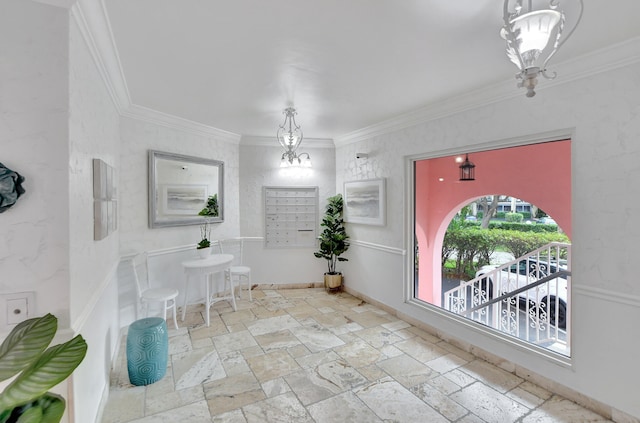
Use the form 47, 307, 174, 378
500, 0, 583, 97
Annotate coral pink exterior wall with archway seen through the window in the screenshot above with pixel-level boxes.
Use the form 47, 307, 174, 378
415, 140, 571, 306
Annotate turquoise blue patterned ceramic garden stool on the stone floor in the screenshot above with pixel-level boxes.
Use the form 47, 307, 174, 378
127, 317, 169, 386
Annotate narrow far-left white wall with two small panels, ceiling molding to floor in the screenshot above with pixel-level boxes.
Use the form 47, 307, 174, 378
68, 11, 121, 422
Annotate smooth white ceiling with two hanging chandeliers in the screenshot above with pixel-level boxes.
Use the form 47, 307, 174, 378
104, 0, 640, 139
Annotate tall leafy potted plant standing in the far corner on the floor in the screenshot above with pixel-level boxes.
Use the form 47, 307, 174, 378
313, 194, 349, 289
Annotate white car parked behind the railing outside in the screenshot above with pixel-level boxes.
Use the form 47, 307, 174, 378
476, 258, 567, 329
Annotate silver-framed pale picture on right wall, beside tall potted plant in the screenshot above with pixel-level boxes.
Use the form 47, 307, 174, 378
344, 178, 386, 226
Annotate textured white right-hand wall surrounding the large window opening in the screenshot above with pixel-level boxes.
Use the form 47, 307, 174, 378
336, 64, 640, 416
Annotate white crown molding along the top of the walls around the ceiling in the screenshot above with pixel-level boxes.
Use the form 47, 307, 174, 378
69, 0, 640, 148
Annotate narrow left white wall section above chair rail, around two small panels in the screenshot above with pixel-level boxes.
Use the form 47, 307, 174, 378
69, 10, 121, 328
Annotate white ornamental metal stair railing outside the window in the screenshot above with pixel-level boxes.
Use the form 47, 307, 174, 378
443, 243, 571, 356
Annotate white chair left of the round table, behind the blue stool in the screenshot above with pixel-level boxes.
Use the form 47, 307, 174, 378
132, 253, 179, 329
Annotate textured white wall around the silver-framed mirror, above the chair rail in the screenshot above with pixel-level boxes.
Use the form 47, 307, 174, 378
119, 117, 240, 255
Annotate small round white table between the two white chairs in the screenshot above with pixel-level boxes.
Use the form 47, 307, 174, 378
182, 254, 236, 326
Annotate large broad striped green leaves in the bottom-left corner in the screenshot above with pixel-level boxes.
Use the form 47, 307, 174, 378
0, 314, 87, 423
